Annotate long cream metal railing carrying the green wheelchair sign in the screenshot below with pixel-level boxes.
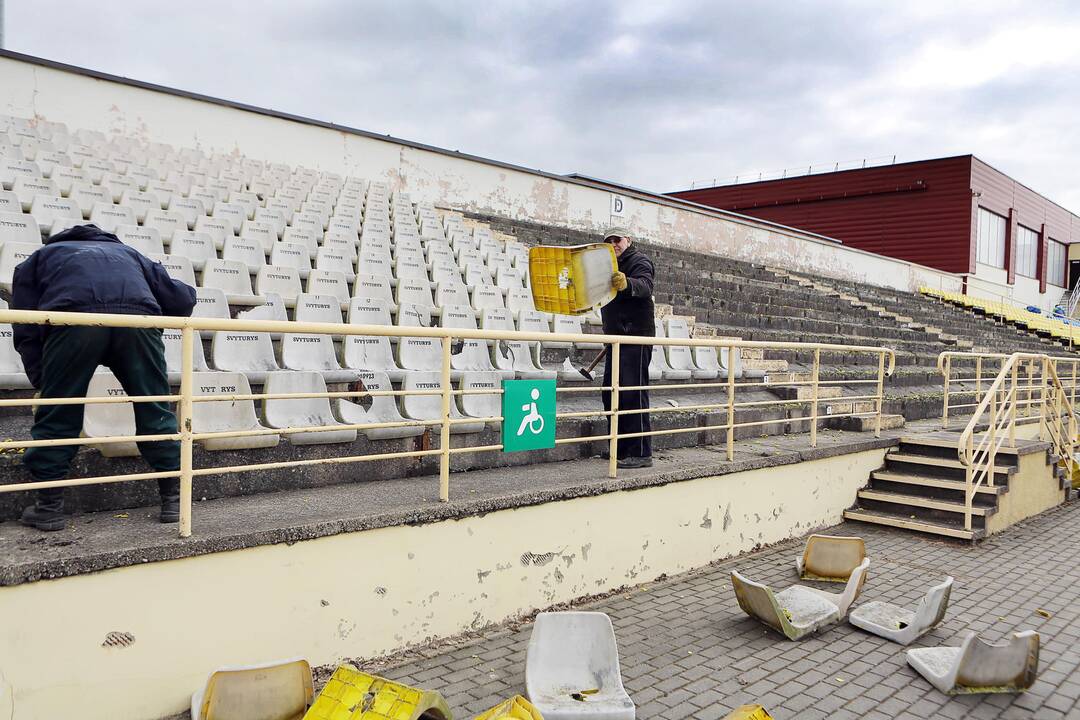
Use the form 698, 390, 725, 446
0, 310, 895, 538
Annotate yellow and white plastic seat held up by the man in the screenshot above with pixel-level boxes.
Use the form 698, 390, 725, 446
529, 243, 618, 315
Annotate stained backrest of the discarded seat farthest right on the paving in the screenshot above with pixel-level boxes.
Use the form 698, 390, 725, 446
956, 630, 1039, 692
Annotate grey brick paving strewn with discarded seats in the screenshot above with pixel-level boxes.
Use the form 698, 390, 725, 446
373, 502, 1080, 720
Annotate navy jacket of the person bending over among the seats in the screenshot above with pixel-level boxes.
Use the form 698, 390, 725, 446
11, 225, 195, 388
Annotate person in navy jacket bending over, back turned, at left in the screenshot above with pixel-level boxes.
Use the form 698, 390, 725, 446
11, 225, 195, 530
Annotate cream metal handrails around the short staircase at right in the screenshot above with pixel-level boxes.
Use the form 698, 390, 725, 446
937, 353, 1078, 530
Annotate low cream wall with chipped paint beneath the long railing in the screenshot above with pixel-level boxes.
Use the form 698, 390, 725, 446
0, 449, 886, 720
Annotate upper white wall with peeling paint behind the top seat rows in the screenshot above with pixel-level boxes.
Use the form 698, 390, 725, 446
0, 57, 960, 291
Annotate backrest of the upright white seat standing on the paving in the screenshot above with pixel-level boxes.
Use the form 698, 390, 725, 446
525, 612, 622, 696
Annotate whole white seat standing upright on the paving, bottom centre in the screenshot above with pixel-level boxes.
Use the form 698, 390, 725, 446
525, 612, 636, 720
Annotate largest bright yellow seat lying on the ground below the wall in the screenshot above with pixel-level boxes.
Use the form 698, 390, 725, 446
303, 665, 454, 720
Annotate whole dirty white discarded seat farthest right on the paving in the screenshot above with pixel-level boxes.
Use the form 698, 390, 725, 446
907, 630, 1039, 695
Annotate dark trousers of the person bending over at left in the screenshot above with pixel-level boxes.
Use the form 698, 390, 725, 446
23, 326, 180, 503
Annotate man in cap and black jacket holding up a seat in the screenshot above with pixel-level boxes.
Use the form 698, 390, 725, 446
600, 228, 657, 467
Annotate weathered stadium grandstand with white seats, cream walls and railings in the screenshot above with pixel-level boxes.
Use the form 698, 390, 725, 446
0, 47, 1080, 720
